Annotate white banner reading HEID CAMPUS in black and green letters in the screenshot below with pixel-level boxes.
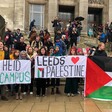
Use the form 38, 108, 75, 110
0, 60, 31, 85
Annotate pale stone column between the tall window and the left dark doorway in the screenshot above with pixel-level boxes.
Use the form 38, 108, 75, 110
48, 0, 58, 33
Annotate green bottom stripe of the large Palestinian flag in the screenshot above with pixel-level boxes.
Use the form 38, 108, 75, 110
87, 86, 112, 100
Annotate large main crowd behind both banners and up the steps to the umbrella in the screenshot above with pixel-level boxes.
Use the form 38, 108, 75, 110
0, 16, 107, 101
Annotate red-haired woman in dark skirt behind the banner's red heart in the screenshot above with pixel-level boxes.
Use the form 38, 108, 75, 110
64, 47, 79, 96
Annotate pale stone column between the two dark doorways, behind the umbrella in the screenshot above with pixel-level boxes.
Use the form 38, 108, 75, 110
79, 0, 88, 35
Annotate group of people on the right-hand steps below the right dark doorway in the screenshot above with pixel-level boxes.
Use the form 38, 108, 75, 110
88, 22, 112, 52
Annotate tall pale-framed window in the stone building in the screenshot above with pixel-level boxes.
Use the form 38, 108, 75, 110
29, 4, 44, 30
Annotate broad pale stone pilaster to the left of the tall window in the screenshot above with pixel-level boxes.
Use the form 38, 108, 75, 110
14, 0, 25, 31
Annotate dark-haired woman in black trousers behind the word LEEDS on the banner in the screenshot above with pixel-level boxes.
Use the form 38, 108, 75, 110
36, 47, 47, 97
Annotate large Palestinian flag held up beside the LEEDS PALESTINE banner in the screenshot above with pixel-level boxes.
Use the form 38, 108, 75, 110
84, 56, 112, 100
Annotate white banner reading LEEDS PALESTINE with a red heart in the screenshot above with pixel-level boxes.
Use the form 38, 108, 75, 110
35, 56, 87, 78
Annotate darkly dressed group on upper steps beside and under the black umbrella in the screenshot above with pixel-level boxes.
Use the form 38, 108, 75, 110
52, 17, 82, 46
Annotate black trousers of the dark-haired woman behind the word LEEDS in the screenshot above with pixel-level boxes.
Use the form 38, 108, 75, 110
36, 78, 46, 96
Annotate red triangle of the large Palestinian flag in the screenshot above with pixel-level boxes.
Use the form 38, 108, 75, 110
85, 58, 112, 96
